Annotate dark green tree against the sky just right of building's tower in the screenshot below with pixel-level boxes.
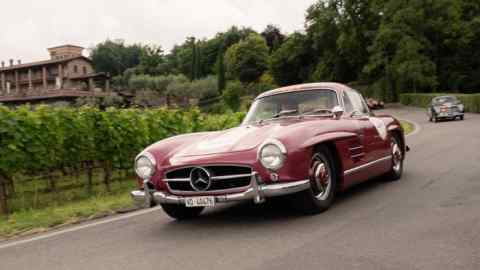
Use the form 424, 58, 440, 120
90, 40, 143, 76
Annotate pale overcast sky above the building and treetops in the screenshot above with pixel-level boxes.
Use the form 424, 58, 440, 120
0, 0, 315, 63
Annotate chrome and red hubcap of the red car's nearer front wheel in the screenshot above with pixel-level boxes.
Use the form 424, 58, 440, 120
311, 156, 332, 200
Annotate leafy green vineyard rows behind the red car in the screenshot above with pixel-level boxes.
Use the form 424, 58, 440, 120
0, 106, 244, 214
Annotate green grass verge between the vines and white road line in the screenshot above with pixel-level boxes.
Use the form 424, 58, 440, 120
0, 171, 136, 239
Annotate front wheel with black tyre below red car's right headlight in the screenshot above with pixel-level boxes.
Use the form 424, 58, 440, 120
293, 147, 337, 214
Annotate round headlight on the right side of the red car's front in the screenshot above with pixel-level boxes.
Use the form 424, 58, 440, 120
258, 139, 287, 171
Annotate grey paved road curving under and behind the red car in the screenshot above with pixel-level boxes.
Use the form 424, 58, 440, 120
0, 108, 480, 270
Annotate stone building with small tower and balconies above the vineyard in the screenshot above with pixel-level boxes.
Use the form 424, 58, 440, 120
0, 45, 110, 104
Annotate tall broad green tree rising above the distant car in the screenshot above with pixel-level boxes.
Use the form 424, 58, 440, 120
364, 0, 461, 100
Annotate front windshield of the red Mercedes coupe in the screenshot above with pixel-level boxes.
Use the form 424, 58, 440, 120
244, 90, 338, 124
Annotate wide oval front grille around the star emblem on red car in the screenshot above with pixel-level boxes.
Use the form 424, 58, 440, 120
164, 165, 252, 193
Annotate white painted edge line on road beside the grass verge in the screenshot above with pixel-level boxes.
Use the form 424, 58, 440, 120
0, 207, 160, 249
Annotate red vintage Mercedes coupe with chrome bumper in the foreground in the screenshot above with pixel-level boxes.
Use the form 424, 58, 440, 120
131, 83, 407, 219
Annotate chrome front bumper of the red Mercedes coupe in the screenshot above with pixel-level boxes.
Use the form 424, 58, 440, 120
130, 173, 310, 207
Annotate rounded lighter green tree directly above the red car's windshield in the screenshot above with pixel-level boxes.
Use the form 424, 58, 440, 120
225, 34, 268, 83
